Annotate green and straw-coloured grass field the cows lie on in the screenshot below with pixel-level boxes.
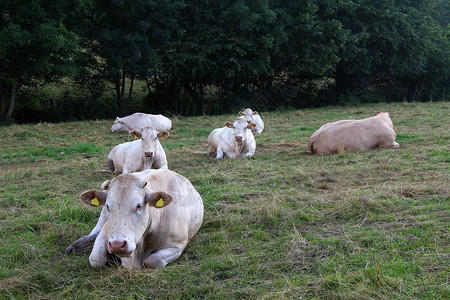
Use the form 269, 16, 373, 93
0, 102, 450, 299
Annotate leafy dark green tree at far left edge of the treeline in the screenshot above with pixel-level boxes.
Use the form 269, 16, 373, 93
0, 0, 76, 118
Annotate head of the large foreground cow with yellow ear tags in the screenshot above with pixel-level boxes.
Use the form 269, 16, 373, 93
80, 174, 173, 257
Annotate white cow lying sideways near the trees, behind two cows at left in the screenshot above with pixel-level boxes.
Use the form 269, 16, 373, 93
111, 113, 172, 132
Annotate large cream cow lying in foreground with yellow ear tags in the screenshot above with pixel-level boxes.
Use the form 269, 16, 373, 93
66, 170, 203, 269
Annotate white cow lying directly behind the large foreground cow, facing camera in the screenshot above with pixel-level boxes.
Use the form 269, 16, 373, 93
107, 126, 169, 173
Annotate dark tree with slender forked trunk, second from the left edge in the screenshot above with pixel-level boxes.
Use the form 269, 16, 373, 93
76, 0, 181, 113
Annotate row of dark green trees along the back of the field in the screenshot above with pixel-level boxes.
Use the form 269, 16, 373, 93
0, 0, 450, 122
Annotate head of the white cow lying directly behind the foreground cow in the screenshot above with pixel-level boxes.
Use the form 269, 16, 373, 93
130, 126, 169, 163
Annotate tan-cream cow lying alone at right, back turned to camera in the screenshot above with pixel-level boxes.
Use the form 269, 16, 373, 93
308, 111, 400, 154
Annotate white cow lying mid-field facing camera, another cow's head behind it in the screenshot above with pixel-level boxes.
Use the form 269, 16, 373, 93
208, 117, 256, 159
